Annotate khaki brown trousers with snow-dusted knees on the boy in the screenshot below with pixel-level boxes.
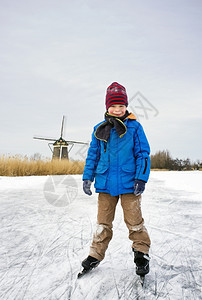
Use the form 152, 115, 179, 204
89, 193, 151, 261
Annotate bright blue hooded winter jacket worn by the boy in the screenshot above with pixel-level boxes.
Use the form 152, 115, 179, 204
83, 113, 150, 196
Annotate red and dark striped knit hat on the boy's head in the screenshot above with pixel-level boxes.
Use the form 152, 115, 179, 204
106, 82, 128, 109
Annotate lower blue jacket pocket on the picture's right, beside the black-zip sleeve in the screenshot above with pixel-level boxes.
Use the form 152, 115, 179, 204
121, 164, 135, 189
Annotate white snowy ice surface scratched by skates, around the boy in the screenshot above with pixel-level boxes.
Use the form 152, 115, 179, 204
0, 171, 202, 300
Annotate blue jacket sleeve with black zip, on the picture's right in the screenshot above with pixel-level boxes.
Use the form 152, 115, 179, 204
134, 124, 151, 182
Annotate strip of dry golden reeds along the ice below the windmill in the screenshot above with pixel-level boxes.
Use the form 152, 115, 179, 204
0, 156, 84, 176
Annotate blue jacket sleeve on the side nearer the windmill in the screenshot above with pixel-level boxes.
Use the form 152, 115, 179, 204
83, 128, 100, 182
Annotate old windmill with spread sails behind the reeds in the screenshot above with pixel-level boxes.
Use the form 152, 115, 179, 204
33, 116, 88, 159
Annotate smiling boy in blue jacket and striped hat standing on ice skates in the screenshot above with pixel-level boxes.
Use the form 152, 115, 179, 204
82, 82, 150, 276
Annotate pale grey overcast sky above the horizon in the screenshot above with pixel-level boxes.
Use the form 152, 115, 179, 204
0, 0, 202, 160
